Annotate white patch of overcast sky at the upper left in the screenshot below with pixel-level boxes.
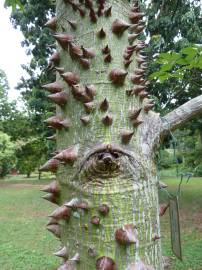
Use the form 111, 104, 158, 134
0, 0, 29, 104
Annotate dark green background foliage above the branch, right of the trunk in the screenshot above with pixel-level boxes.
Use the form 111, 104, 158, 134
145, 0, 202, 113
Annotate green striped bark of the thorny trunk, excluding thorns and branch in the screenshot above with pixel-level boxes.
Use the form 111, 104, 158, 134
42, 0, 163, 270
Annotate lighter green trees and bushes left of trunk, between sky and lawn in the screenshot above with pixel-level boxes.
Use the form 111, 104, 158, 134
0, 70, 52, 177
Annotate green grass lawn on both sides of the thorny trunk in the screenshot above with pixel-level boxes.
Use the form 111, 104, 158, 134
0, 175, 202, 270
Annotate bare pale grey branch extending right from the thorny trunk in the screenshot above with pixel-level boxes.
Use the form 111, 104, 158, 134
161, 95, 202, 136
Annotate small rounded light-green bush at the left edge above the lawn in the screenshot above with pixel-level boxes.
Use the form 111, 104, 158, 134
0, 131, 16, 178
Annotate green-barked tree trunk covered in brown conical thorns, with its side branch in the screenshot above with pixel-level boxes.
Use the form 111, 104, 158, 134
41, 0, 202, 270
